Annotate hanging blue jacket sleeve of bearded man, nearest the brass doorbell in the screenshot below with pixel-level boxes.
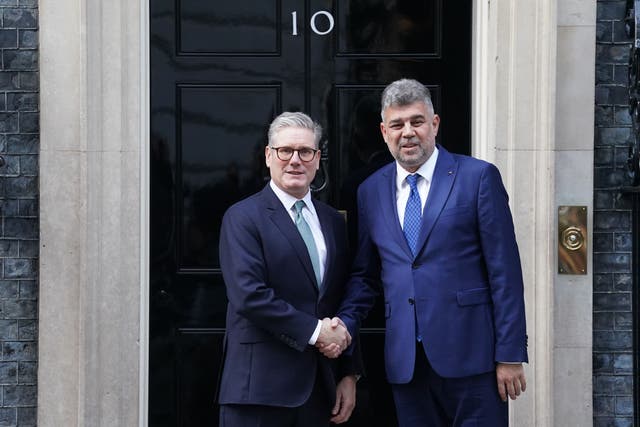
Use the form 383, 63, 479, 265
478, 164, 528, 362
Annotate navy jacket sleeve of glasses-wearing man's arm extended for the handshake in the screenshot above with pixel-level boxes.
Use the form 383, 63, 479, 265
220, 208, 318, 351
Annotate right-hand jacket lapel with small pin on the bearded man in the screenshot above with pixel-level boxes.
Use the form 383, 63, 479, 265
418, 146, 458, 252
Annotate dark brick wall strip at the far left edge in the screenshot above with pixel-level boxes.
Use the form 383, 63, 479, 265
0, 0, 37, 426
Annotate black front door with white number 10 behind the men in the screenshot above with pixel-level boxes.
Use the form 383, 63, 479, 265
149, 0, 471, 427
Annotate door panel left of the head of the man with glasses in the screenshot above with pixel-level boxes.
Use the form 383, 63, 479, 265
176, 84, 280, 274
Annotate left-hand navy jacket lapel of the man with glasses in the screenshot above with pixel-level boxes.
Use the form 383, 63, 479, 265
262, 184, 318, 291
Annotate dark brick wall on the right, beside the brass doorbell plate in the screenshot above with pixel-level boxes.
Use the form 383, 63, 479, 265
593, 0, 633, 427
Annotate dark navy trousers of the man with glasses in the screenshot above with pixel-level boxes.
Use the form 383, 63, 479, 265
220, 379, 332, 427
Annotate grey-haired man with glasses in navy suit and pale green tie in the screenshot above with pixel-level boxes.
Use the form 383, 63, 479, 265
219, 112, 361, 427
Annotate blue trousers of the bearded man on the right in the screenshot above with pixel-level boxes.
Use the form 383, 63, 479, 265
392, 343, 509, 427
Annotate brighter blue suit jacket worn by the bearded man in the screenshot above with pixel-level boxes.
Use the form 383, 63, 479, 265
339, 146, 527, 383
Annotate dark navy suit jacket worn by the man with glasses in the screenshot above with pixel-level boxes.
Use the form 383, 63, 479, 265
219, 185, 360, 408
